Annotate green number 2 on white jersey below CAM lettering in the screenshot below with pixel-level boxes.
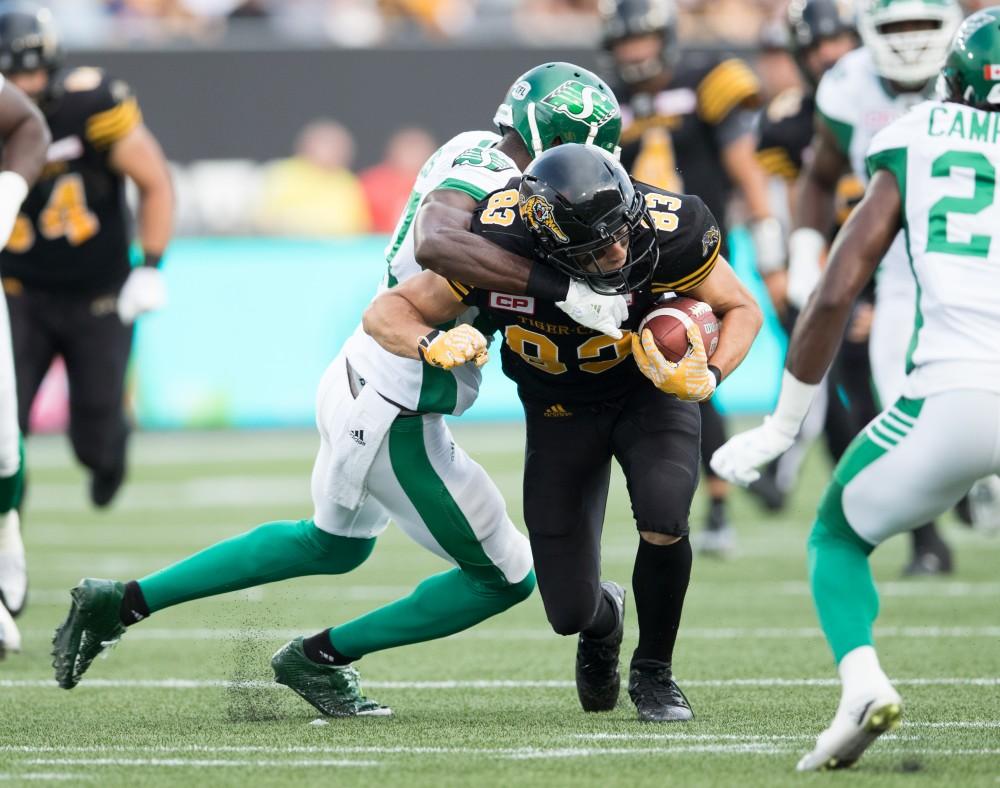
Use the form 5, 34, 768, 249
927, 150, 996, 257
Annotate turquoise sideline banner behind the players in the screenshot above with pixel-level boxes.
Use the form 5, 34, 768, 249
130, 232, 785, 429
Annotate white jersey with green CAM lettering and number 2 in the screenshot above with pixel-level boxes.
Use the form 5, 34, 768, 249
868, 101, 1000, 398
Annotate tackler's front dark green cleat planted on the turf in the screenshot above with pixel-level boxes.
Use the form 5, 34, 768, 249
271, 637, 392, 717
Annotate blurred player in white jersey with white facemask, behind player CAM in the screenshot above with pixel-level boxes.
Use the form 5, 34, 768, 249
788, 0, 962, 574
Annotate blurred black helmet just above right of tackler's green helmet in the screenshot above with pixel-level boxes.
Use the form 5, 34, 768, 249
600, 0, 680, 85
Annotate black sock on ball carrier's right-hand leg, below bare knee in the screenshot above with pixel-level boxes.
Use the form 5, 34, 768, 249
632, 536, 691, 664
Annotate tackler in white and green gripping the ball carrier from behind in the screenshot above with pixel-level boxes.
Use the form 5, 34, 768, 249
53, 63, 627, 716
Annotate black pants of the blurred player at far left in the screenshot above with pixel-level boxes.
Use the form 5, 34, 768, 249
5, 283, 132, 474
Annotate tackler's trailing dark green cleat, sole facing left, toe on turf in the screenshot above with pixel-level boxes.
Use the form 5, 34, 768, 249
52, 577, 125, 689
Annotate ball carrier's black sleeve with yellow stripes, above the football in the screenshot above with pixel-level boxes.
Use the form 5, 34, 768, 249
651, 194, 722, 293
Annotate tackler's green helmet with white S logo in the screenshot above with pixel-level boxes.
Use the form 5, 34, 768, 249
493, 63, 622, 157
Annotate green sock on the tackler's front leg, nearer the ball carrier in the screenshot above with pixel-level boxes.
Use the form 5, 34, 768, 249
329, 568, 535, 659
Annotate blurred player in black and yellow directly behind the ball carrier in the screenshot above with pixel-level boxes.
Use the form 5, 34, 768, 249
601, 0, 785, 554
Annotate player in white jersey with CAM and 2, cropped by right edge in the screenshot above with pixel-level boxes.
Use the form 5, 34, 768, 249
712, 7, 1000, 771
